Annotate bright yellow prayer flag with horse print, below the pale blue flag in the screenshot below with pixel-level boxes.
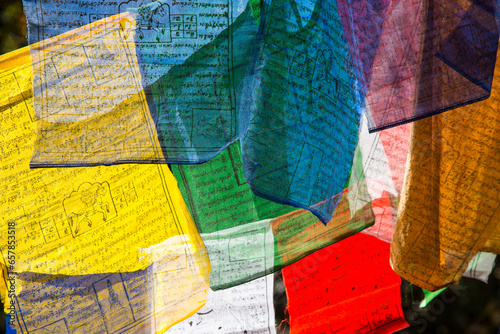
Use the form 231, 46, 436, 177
0, 15, 209, 280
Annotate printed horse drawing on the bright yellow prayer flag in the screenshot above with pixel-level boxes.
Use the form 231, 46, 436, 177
63, 182, 116, 235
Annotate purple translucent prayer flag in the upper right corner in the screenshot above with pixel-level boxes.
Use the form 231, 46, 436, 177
338, 0, 499, 131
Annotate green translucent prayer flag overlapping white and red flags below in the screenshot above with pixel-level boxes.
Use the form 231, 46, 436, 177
172, 138, 376, 290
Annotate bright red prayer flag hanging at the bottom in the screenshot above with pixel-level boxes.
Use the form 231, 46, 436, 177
283, 233, 409, 334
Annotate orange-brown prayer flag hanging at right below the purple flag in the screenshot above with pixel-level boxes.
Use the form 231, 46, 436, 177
391, 48, 500, 291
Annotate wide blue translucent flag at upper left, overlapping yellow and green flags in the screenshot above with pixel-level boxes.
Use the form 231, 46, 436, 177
24, 0, 250, 167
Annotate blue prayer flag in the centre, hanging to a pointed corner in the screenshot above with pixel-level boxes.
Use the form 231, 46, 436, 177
237, 0, 363, 224
